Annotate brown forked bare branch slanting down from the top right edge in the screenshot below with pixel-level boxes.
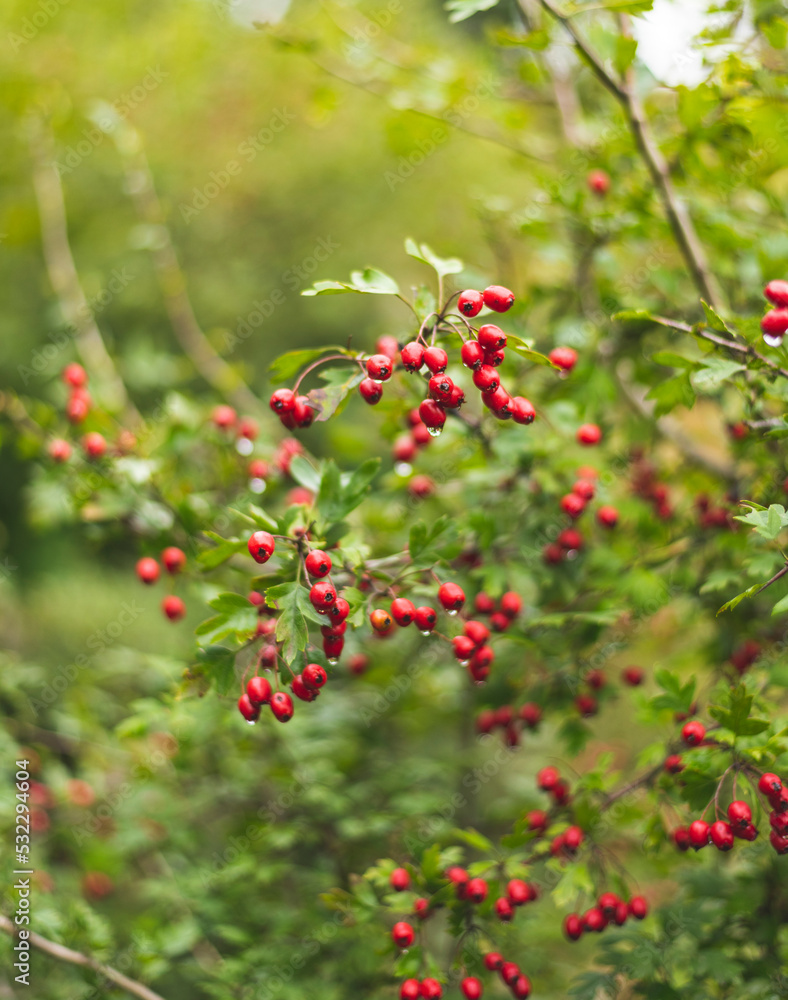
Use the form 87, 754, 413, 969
536, 0, 721, 310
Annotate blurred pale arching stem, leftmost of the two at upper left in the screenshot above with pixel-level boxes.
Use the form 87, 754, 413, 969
29, 118, 142, 425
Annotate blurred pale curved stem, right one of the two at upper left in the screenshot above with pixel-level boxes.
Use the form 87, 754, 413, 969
107, 123, 262, 413
